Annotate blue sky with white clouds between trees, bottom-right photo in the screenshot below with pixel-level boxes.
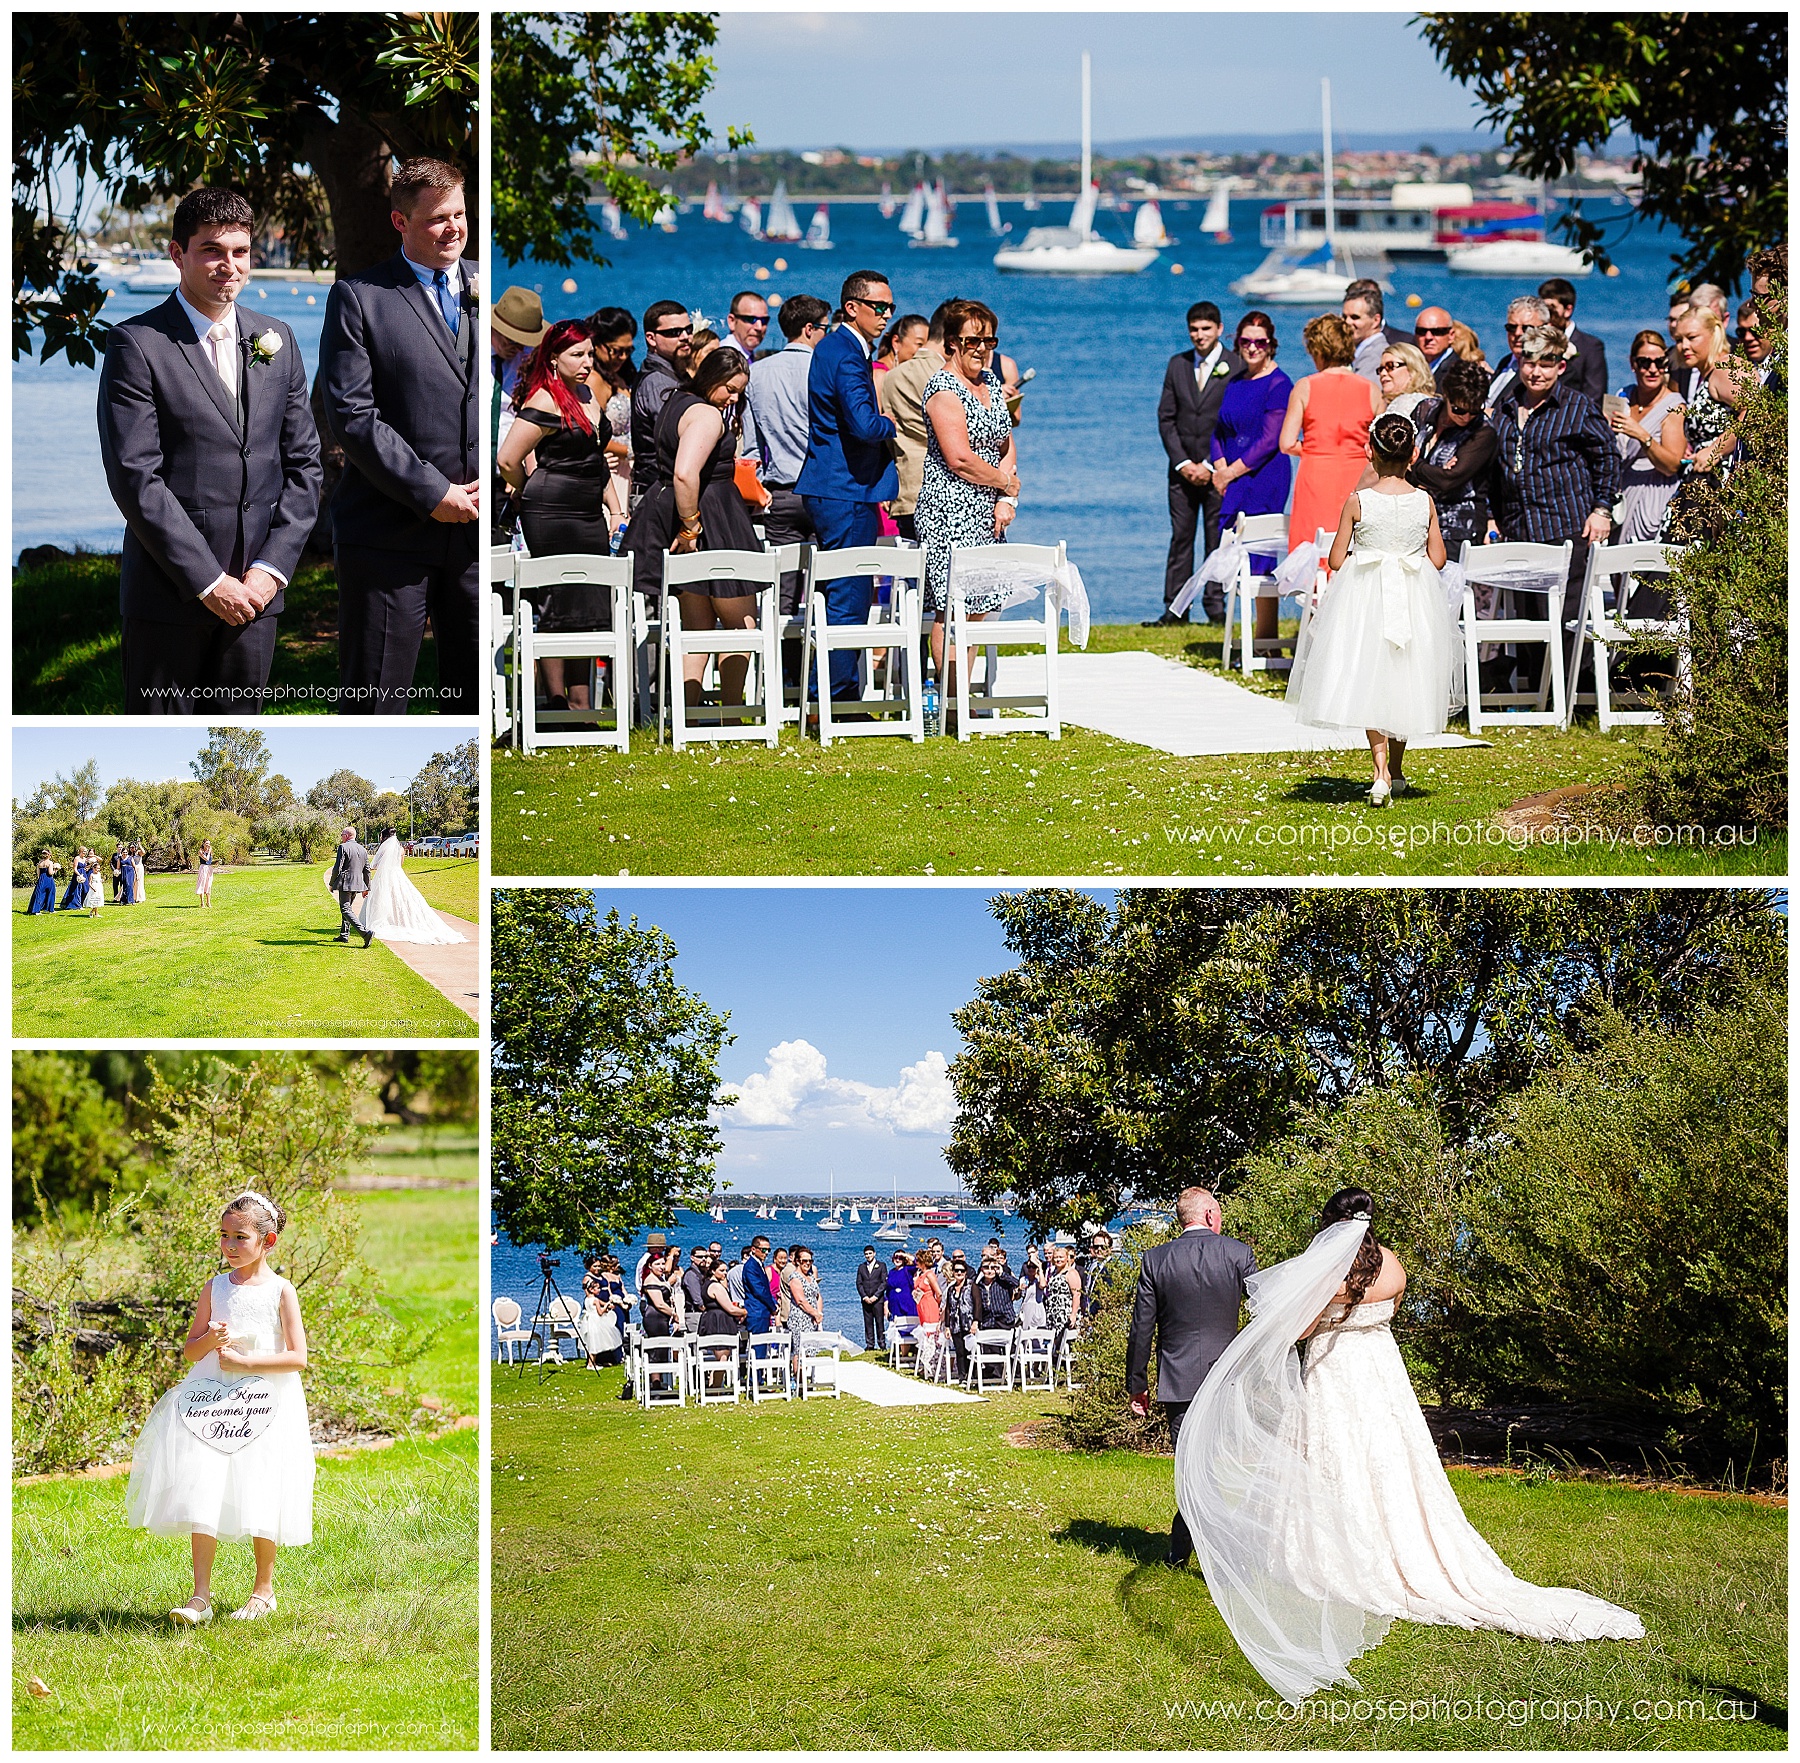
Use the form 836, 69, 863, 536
596, 886, 1111, 1194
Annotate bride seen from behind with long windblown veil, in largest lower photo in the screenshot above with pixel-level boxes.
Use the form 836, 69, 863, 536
1175, 1189, 1643, 1702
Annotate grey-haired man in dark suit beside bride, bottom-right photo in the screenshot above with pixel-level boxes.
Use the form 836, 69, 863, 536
1125, 1187, 1256, 1567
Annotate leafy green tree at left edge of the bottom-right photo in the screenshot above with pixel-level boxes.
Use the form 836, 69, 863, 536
491, 890, 731, 1250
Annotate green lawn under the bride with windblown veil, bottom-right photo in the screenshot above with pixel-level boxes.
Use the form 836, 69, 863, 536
491, 1367, 1787, 1752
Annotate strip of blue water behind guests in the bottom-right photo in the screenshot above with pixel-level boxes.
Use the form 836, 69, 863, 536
488, 1201, 1123, 1349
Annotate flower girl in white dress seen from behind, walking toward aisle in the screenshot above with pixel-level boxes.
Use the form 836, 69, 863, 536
1287, 414, 1454, 807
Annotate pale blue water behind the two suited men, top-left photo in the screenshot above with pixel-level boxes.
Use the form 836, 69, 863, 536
13, 281, 331, 562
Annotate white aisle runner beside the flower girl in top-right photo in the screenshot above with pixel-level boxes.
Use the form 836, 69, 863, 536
1001, 648, 1487, 758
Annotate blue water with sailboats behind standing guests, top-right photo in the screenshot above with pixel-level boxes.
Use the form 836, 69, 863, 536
493, 196, 1676, 621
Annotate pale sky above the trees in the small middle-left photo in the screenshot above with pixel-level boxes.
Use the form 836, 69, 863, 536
13, 717, 468, 801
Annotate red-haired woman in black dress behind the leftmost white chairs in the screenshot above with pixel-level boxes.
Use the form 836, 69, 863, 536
495, 319, 623, 710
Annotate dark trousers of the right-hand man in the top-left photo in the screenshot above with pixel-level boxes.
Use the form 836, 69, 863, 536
333, 544, 481, 717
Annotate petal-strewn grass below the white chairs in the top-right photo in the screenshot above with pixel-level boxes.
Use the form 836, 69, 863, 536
493, 625, 1787, 877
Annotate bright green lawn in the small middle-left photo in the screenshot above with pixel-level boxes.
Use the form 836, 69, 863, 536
13, 859, 477, 1041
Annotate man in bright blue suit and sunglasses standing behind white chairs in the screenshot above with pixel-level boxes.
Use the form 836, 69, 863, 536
794, 270, 900, 699
